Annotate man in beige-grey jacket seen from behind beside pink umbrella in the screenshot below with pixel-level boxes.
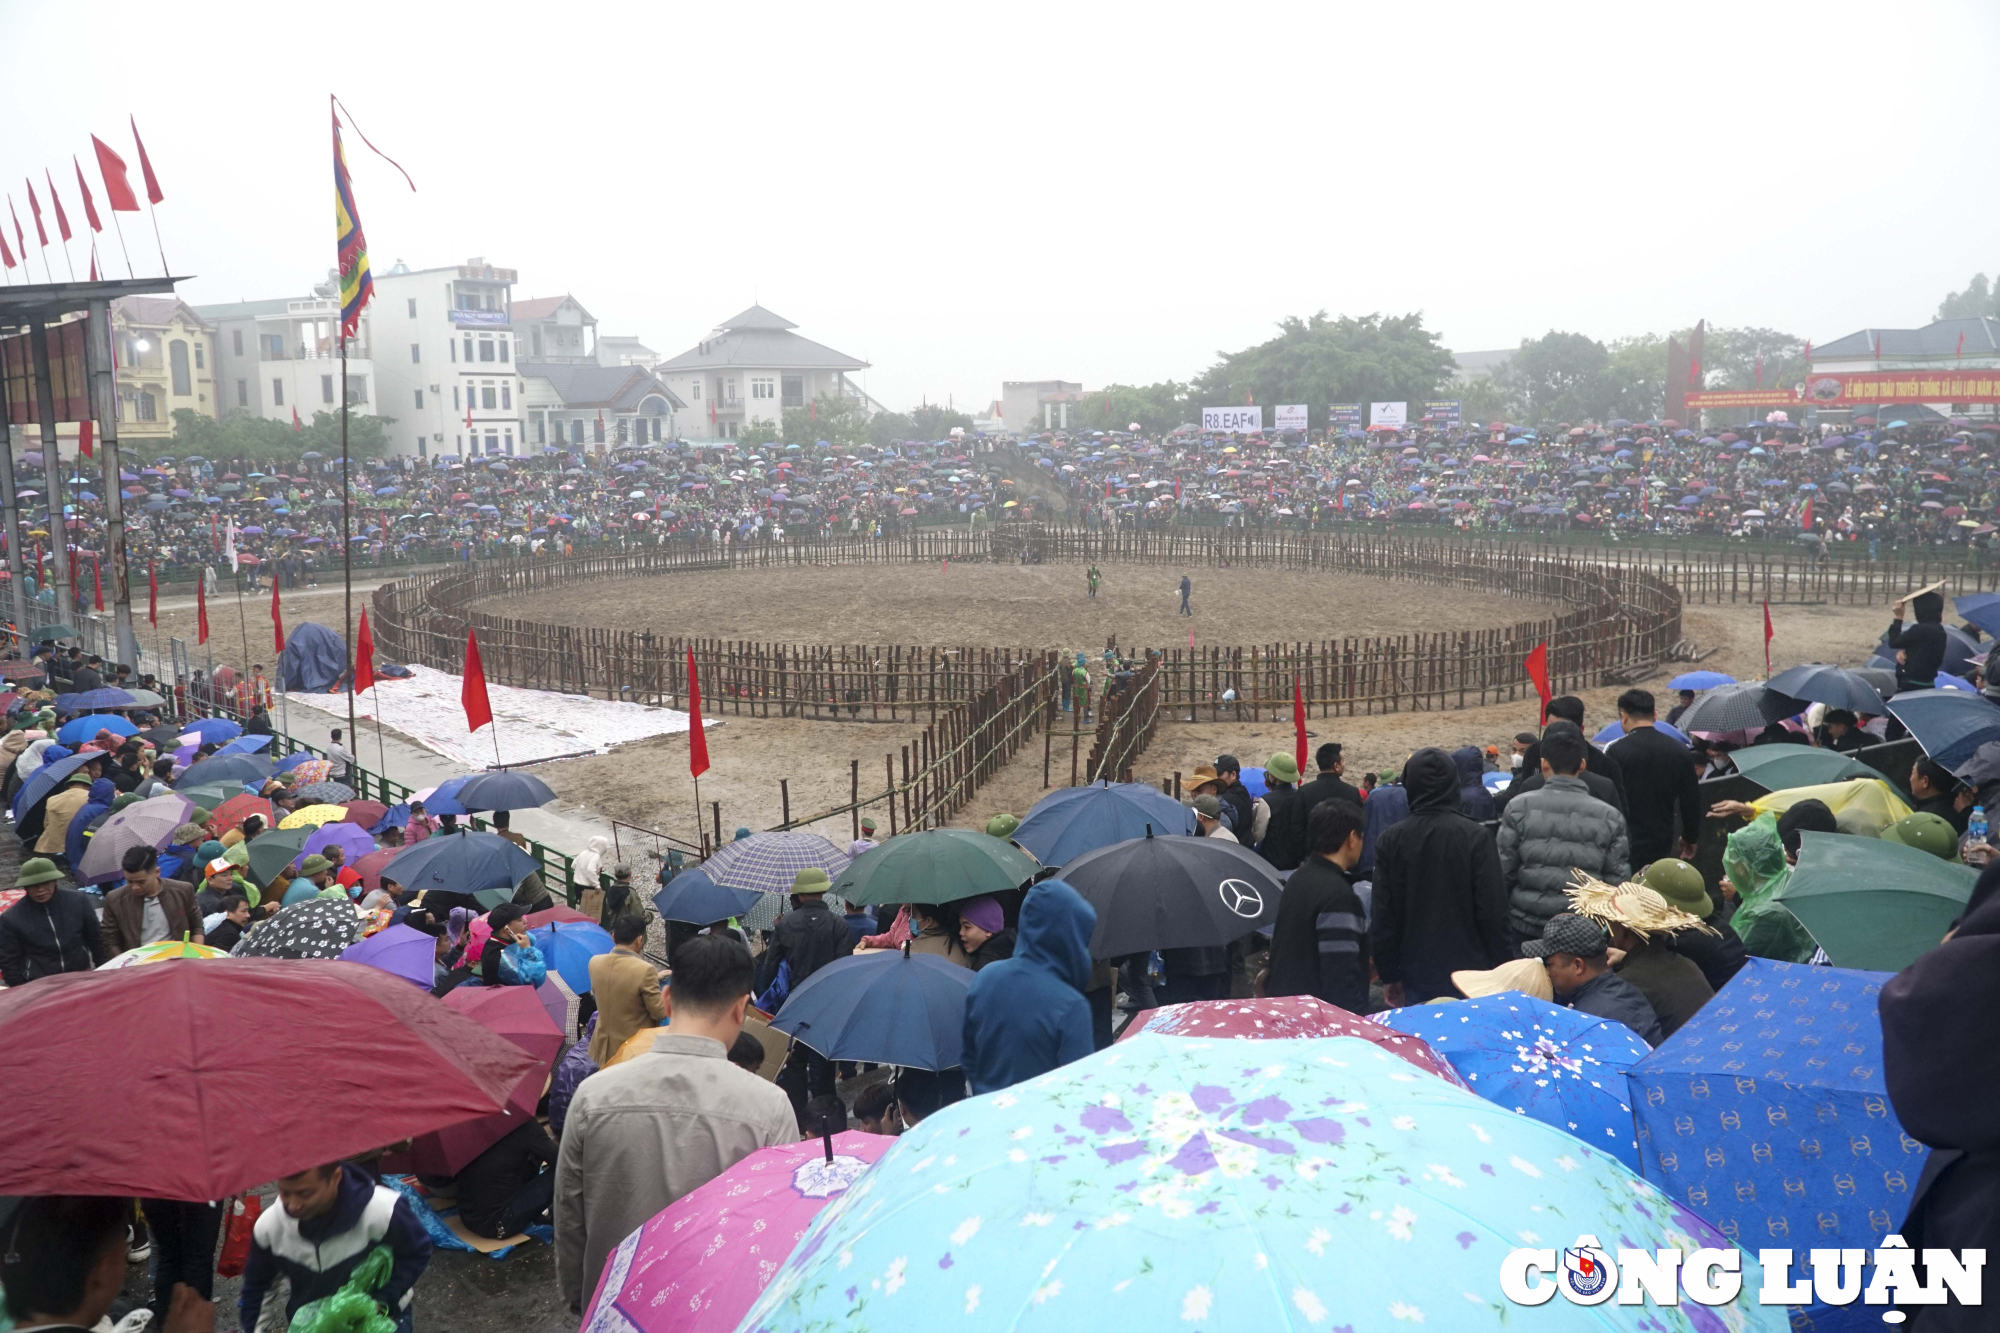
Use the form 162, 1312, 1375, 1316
556, 935, 798, 1313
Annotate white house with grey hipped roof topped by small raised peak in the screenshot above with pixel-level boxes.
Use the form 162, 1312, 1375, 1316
654, 306, 882, 440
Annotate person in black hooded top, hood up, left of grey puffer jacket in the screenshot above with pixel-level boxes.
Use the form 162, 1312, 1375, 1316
1370, 749, 1508, 1005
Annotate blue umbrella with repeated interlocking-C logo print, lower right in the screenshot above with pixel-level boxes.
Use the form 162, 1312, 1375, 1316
1630, 956, 1930, 1329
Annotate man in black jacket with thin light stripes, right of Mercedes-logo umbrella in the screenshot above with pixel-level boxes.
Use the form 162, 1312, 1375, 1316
1264, 801, 1380, 1000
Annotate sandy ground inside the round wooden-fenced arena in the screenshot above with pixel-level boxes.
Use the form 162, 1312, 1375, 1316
482, 564, 1550, 648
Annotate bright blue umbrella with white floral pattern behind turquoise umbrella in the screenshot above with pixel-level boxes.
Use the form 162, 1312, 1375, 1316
1382, 991, 1650, 1169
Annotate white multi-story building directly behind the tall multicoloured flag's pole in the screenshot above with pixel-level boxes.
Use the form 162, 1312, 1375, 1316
196, 274, 376, 420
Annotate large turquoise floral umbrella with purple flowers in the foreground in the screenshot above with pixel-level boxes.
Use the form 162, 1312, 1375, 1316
740, 1033, 1786, 1333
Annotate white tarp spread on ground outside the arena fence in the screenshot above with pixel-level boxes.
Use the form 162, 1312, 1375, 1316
278, 667, 688, 769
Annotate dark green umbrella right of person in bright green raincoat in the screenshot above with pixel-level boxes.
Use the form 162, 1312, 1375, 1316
1778, 833, 1978, 973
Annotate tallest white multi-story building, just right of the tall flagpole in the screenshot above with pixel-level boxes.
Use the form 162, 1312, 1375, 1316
370, 258, 524, 456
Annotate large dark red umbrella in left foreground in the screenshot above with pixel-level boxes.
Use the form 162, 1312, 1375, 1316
0, 959, 546, 1199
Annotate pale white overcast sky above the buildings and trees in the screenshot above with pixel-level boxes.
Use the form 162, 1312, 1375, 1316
0, 0, 2000, 408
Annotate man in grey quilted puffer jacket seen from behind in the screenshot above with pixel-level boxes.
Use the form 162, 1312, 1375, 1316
1498, 727, 1632, 949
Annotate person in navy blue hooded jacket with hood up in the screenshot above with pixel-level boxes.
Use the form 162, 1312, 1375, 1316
962, 879, 1098, 1093
